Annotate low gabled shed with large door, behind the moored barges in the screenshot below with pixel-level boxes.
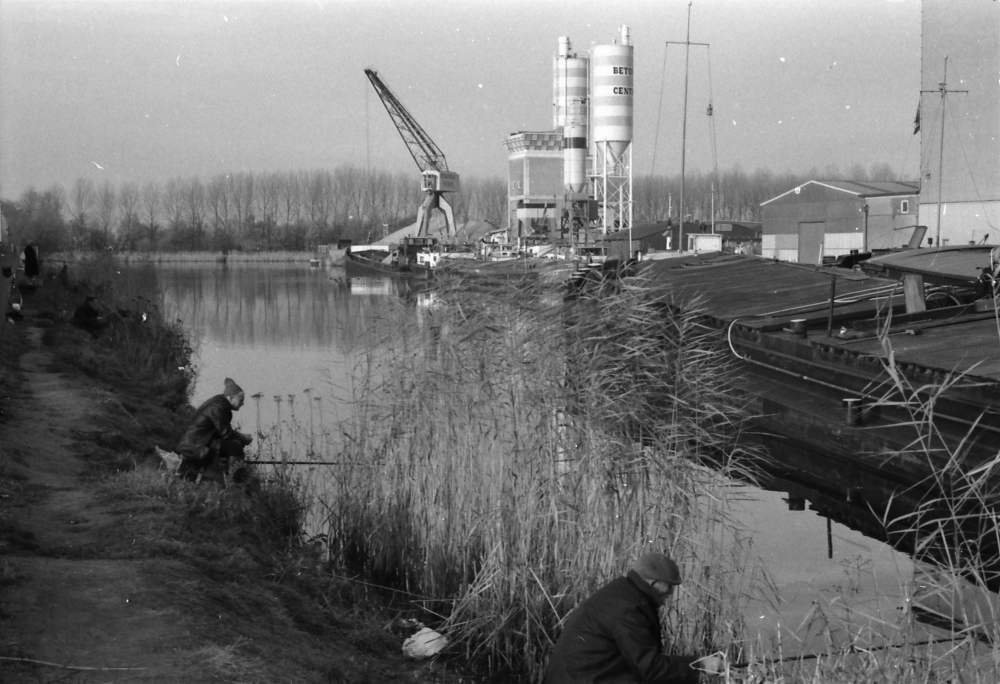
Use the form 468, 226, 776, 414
760, 181, 920, 264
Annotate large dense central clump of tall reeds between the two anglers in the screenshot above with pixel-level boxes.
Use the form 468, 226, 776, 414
312, 268, 762, 680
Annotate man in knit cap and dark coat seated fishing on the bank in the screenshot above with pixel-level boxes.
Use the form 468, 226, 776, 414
176, 378, 253, 483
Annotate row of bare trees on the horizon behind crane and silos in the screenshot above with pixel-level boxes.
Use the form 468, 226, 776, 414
3, 164, 897, 252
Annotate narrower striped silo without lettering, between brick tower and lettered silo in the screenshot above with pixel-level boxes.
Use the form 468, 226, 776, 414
552, 36, 590, 192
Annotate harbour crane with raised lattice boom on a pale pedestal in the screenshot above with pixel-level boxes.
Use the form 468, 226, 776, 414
365, 69, 460, 237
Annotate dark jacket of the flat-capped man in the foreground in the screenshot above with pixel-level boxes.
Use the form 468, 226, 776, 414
544, 571, 699, 684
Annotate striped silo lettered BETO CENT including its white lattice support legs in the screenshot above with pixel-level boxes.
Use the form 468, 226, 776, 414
590, 26, 635, 232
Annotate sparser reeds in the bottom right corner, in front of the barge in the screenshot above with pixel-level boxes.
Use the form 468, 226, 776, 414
752, 296, 1000, 684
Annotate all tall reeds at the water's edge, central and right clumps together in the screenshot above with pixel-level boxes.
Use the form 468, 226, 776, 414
227, 260, 1000, 684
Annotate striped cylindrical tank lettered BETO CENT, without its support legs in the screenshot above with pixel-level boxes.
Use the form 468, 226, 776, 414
591, 26, 635, 163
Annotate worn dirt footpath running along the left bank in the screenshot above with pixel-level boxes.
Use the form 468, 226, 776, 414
0, 328, 218, 684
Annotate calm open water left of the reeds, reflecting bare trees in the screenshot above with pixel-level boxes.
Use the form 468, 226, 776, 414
157, 263, 414, 432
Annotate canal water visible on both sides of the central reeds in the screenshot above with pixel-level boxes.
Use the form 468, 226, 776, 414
159, 263, 914, 656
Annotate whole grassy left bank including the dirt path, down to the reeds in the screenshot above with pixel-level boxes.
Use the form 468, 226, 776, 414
0, 270, 457, 682
